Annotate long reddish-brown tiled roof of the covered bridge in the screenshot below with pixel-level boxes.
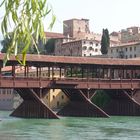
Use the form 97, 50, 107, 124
0, 54, 140, 66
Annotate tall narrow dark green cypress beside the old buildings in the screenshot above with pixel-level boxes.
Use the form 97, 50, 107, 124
101, 29, 110, 54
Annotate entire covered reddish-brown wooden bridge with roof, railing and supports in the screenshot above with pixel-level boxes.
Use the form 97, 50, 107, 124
0, 54, 140, 118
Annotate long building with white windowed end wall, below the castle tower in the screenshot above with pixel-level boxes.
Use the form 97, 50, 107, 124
55, 39, 101, 56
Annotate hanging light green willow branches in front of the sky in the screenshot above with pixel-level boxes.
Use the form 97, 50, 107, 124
0, 0, 55, 65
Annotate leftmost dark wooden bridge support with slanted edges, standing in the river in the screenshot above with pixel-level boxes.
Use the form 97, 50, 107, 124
11, 89, 58, 119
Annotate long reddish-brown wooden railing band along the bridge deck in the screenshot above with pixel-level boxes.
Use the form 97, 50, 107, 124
0, 76, 140, 89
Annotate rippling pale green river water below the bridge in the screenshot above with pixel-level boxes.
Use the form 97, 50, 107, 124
0, 111, 140, 140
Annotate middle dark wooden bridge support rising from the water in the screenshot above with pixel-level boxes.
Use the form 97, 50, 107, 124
57, 89, 109, 117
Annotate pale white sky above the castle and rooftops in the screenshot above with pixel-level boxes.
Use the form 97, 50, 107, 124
0, 0, 140, 33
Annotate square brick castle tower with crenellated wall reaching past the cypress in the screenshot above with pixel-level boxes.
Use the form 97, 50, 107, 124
63, 19, 119, 43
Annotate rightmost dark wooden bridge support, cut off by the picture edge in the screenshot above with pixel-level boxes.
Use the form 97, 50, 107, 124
102, 90, 140, 116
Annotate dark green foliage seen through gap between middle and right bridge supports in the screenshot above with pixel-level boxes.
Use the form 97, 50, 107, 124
92, 90, 111, 108
